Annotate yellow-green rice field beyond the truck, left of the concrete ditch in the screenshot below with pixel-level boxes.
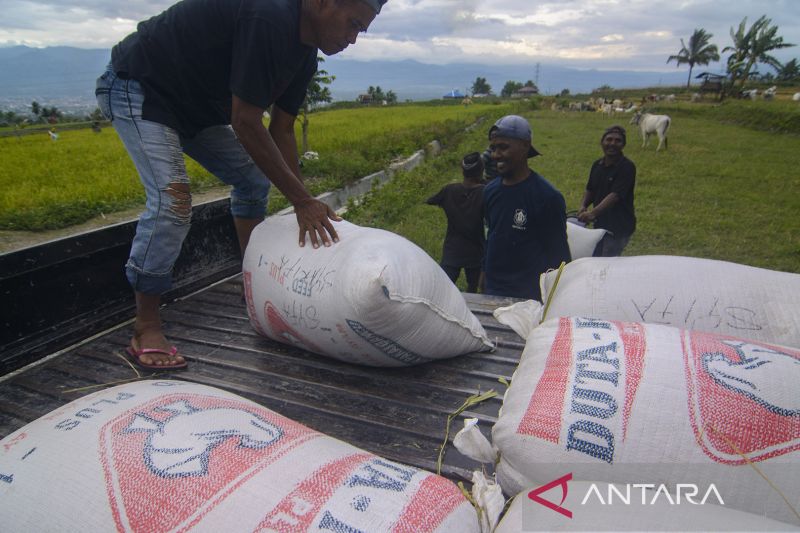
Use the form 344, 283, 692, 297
0, 105, 511, 231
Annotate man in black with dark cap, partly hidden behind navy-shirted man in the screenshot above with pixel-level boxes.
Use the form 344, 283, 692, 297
427, 152, 486, 292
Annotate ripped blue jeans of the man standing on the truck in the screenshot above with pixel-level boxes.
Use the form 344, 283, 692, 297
95, 65, 270, 294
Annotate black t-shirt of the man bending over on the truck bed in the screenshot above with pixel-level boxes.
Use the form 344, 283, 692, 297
111, 0, 317, 136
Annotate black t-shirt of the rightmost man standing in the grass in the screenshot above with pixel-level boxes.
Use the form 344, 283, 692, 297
586, 156, 636, 236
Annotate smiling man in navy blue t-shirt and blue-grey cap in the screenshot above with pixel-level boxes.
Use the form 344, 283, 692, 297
483, 115, 570, 300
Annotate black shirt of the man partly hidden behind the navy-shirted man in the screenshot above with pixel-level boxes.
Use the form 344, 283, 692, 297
427, 183, 486, 268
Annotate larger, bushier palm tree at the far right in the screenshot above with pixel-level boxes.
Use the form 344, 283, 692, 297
722, 15, 794, 91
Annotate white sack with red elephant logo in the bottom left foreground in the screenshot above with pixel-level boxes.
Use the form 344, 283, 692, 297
0, 381, 478, 533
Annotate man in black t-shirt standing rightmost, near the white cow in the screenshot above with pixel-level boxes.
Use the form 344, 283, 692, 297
578, 125, 636, 257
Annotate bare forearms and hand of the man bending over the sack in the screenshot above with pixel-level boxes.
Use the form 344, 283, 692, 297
231, 95, 341, 248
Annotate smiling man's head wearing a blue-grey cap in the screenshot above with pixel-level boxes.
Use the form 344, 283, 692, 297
489, 115, 539, 177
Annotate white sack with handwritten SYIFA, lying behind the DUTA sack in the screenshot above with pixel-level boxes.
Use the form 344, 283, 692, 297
540, 255, 800, 346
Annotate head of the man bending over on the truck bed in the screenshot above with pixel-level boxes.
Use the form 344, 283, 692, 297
300, 0, 386, 56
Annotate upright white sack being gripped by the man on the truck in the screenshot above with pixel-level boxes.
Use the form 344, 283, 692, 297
243, 215, 492, 366
